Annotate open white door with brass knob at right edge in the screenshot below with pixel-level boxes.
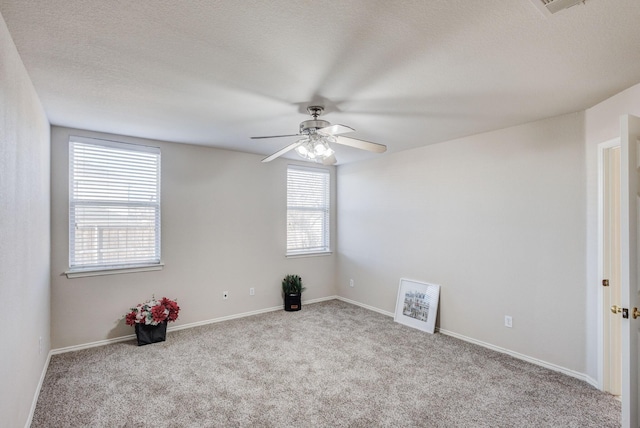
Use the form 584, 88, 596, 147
620, 115, 640, 428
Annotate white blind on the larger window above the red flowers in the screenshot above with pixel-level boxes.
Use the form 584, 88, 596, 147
69, 137, 160, 271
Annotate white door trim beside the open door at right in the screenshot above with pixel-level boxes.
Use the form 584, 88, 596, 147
587, 137, 620, 391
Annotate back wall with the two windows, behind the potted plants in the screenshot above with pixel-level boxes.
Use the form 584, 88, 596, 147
51, 127, 335, 349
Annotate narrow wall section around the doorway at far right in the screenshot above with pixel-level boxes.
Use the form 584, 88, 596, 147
585, 84, 640, 379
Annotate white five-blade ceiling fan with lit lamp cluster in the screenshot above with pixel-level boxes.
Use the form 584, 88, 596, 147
251, 106, 387, 165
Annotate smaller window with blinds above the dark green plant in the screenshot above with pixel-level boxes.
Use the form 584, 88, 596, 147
287, 165, 330, 256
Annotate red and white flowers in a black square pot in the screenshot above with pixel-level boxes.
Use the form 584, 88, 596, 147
125, 297, 180, 346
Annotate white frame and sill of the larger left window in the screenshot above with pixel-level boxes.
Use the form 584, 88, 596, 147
65, 135, 164, 278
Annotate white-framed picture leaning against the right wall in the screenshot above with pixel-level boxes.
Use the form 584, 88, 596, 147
393, 278, 440, 334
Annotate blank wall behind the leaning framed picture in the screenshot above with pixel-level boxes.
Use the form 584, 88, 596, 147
337, 113, 586, 373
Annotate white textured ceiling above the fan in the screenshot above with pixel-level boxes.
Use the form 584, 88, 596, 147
0, 0, 640, 163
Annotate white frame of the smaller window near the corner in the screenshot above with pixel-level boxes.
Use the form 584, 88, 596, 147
286, 164, 332, 257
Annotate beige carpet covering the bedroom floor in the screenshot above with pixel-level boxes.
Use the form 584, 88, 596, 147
32, 300, 620, 428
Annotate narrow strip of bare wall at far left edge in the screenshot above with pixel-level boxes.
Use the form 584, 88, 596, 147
0, 10, 50, 427
